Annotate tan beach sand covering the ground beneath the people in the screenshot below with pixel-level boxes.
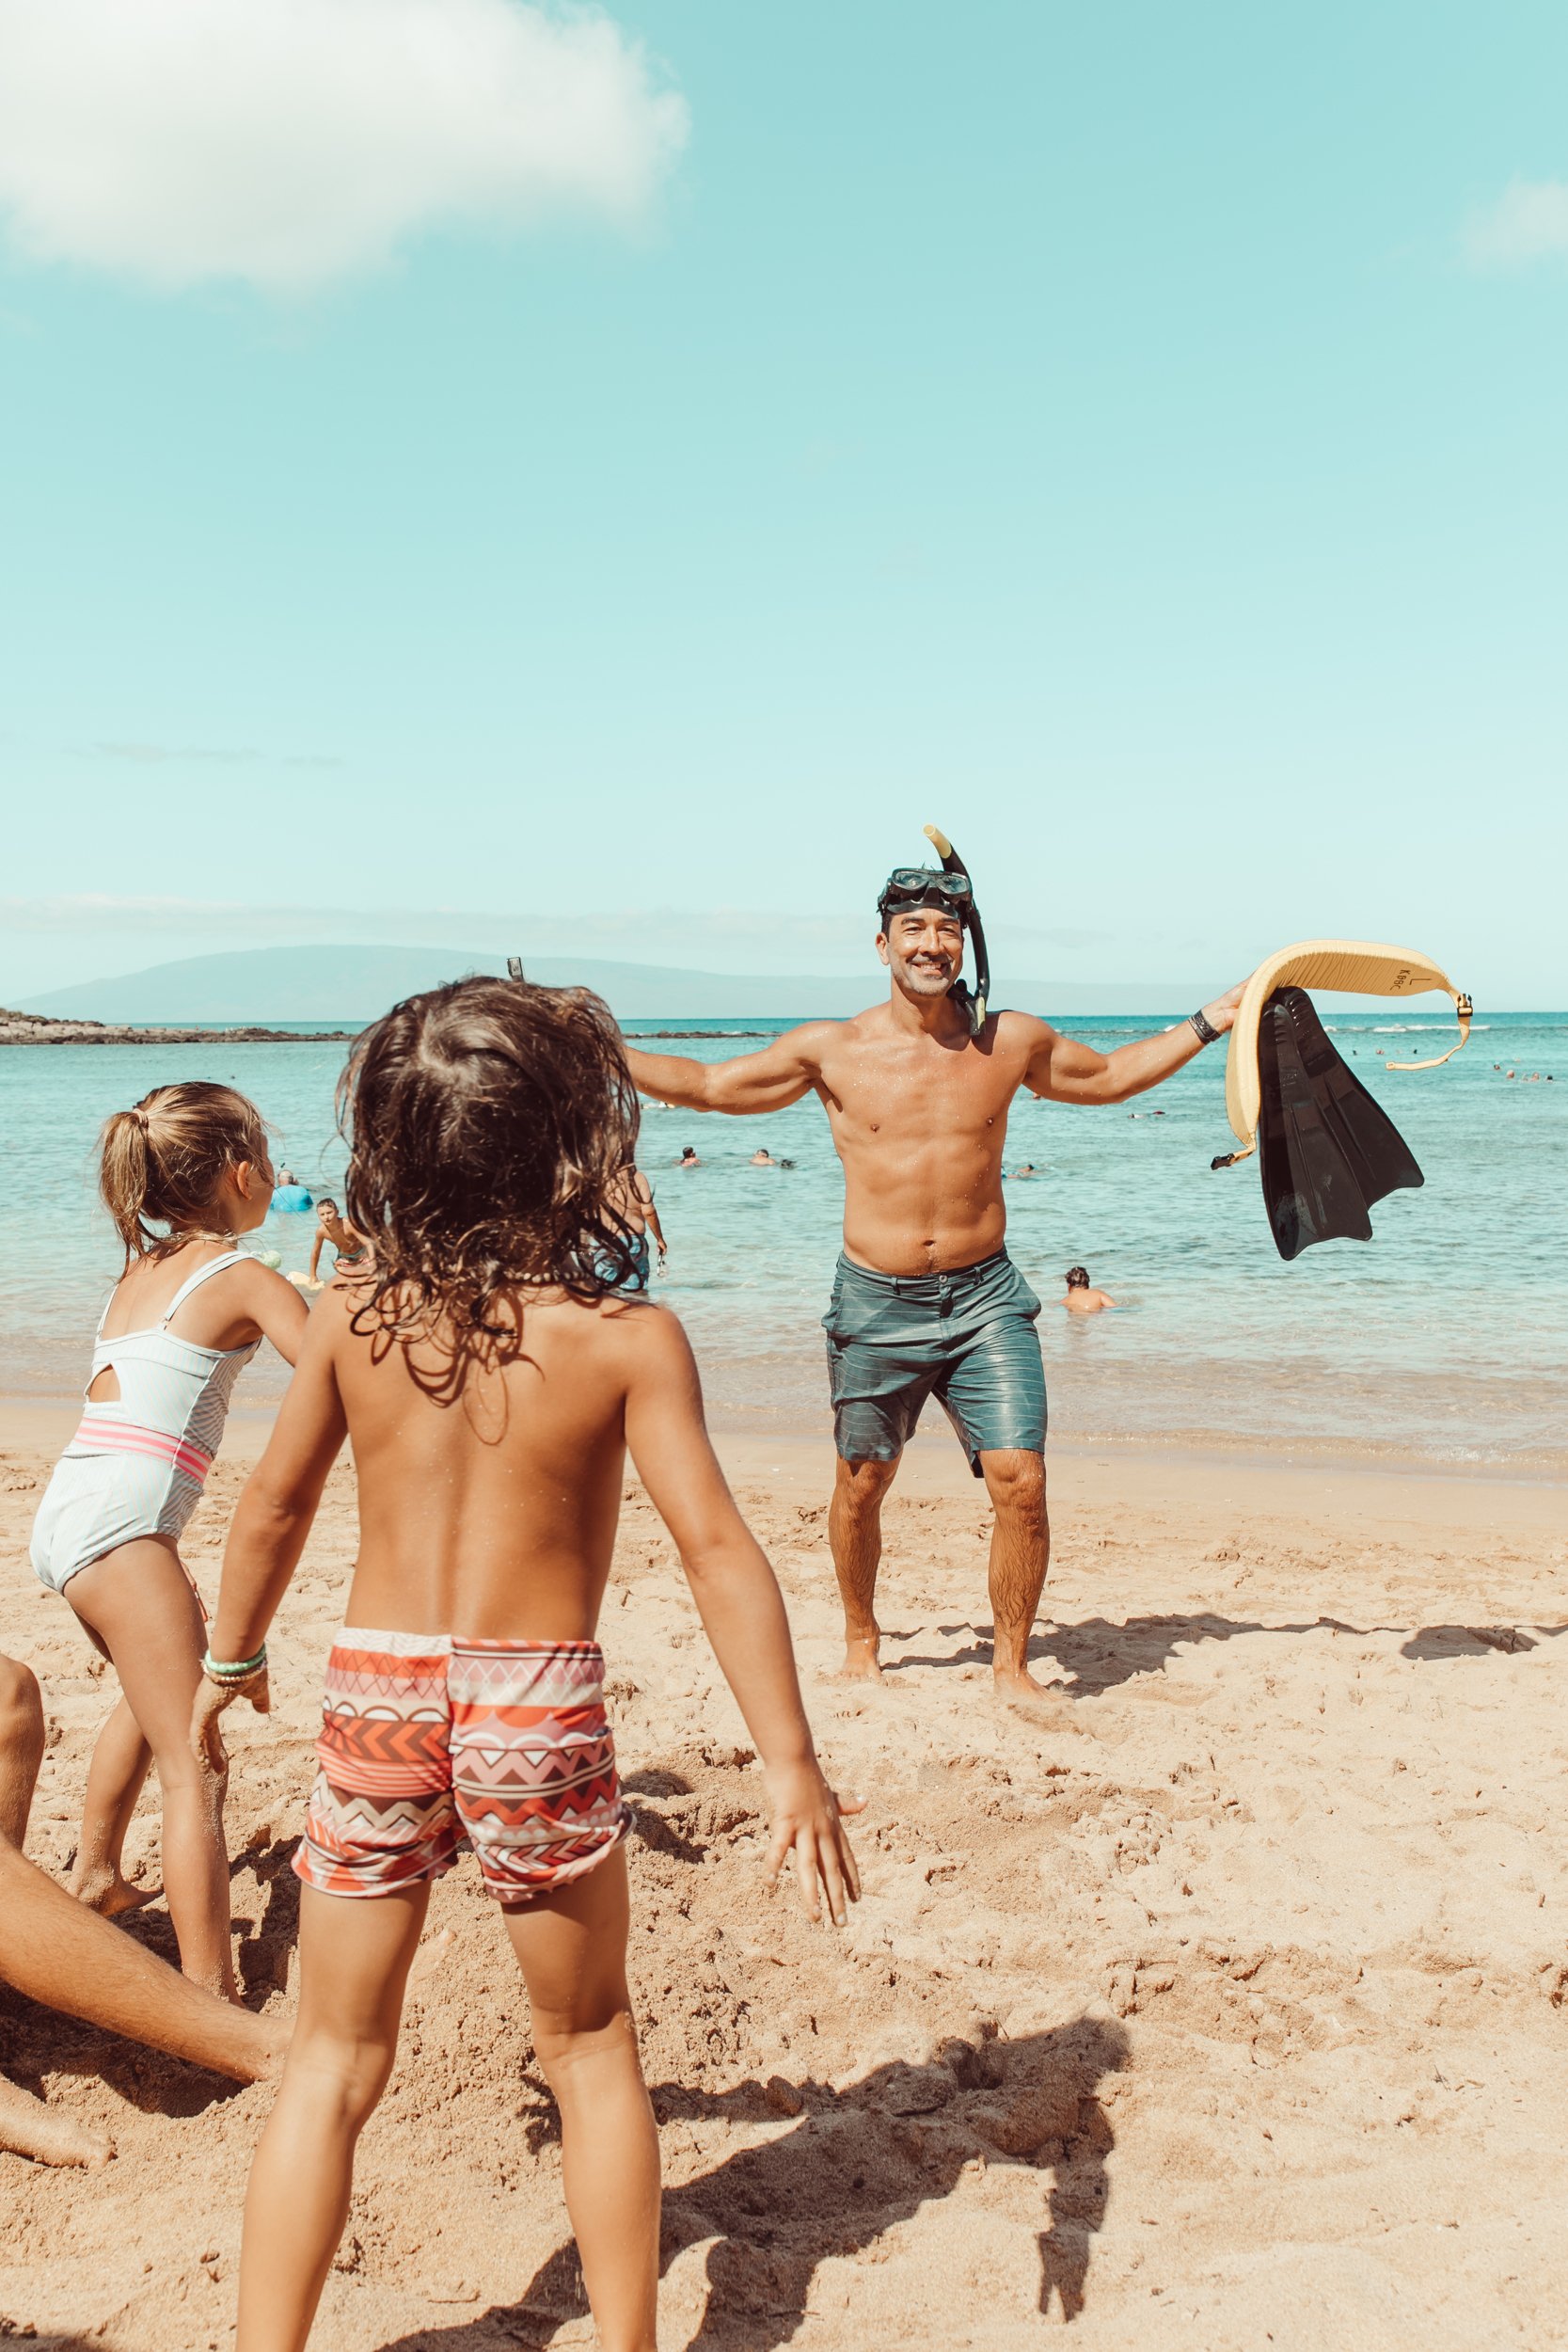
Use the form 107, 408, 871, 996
0, 1414, 1568, 2352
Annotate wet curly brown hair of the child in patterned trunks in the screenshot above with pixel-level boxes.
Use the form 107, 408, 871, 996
339, 978, 637, 1372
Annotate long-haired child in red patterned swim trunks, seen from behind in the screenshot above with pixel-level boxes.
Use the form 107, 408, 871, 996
193, 978, 858, 2352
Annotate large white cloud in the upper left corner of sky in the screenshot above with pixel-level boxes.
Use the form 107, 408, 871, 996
0, 0, 687, 292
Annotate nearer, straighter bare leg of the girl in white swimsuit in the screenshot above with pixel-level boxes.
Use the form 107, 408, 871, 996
66, 1536, 237, 2002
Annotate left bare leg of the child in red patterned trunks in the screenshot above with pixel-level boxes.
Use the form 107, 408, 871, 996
235, 1882, 430, 2352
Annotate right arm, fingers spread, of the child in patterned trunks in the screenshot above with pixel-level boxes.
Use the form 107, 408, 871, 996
626, 1312, 861, 1927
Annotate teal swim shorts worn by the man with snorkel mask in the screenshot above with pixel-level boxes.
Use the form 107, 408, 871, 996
823, 1249, 1046, 1477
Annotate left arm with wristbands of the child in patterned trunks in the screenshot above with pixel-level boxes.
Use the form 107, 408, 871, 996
190, 1278, 348, 1762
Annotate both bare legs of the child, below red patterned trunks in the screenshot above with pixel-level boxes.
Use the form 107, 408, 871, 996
237, 1847, 658, 2352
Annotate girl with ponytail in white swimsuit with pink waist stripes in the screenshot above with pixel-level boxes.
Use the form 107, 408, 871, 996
33, 1082, 308, 2002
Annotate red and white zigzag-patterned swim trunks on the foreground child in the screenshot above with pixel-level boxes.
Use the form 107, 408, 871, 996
293, 1626, 630, 1910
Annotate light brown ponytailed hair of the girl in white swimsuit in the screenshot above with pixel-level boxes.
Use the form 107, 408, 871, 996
99, 1080, 265, 1265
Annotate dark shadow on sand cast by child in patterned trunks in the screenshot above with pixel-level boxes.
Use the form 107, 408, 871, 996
383, 2018, 1126, 2352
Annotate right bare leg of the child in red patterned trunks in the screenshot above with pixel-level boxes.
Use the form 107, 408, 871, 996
505, 1847, 658, 2352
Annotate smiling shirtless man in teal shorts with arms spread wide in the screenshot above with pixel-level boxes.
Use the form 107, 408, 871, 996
626, 868, 1242, 1712
